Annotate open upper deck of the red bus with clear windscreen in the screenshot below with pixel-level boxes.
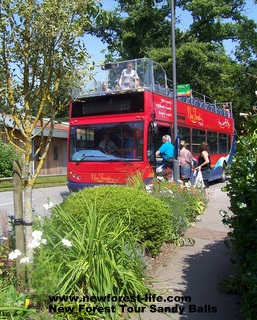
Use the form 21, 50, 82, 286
73, 58, 232, 117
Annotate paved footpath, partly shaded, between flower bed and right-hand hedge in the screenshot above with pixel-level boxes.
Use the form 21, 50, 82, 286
132, 183, 241, 320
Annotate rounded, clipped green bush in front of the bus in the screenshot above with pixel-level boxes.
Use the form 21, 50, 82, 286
56, 186, 172, 255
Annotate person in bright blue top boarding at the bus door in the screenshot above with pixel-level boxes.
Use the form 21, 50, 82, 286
155, 134, 174, 173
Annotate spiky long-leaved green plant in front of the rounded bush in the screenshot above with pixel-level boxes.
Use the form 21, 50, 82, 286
31, 202, 148, 319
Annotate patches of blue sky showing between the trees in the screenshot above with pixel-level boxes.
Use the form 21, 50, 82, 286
85, 0, 257, 63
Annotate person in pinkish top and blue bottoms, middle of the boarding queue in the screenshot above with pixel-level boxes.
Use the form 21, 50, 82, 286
179, 140, 192, 182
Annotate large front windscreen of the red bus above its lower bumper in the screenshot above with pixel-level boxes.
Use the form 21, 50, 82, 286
70, 122, 143, 162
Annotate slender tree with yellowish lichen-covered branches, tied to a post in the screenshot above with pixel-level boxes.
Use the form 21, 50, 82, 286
0, 0, 101, 257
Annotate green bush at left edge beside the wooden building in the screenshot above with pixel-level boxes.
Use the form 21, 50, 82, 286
0, 139, 21, 178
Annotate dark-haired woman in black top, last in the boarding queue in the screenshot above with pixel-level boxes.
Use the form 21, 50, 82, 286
195, 142, 211, 199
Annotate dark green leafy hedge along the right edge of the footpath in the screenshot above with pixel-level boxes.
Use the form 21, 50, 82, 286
221, 117, 257, 319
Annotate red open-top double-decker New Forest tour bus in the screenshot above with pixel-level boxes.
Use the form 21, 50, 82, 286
67, 59, 235, 191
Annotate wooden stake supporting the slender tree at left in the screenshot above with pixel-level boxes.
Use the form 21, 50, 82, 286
13, 160, 26, 290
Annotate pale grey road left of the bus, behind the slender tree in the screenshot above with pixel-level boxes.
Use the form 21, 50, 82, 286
0, 186, 70, 215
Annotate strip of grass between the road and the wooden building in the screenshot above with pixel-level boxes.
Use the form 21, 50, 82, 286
0, 175, 67, 192
